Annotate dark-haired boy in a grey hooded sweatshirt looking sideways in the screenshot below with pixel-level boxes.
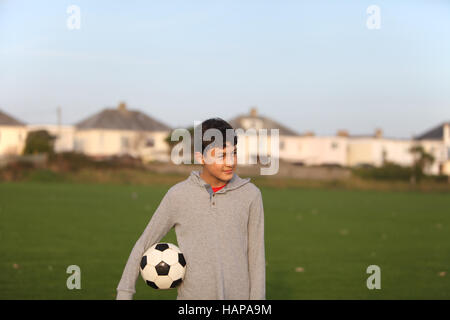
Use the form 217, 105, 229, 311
117, 118, 266, 300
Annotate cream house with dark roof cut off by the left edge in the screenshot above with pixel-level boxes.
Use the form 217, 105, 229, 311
0, 110, 27, 157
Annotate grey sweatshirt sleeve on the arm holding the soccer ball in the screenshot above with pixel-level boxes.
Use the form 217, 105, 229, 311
116, 190, 174, 300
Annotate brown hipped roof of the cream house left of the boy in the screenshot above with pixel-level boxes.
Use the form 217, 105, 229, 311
76, 104, 171, 131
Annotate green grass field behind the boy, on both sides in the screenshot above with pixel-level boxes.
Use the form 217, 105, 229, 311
0, 182, 450, 299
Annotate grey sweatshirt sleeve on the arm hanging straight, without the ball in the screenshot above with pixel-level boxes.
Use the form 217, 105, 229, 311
248, 190, 266, 300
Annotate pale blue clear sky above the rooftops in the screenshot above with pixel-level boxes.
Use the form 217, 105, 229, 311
0, 0, 450, 138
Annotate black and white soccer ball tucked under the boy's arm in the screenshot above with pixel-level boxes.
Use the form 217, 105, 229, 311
140, 243, 186, 289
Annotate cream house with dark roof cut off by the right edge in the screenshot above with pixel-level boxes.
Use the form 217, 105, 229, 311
414, 122, 450, 176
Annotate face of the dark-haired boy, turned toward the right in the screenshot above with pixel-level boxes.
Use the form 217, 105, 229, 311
201, 142, 237, 181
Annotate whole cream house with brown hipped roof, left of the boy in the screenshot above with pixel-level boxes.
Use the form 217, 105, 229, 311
74, 103, 171, 161
